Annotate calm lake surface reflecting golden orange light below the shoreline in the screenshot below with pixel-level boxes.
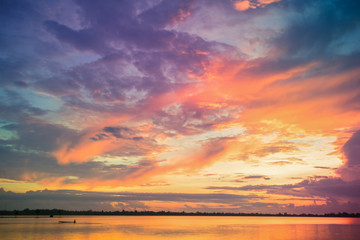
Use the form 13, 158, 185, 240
0, 216, 360, 240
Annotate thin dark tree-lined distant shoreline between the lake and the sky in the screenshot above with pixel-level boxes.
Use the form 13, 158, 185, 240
0, 209, 360, 218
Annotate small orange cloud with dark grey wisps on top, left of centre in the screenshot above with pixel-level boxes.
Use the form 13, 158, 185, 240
53, 121, 164, 164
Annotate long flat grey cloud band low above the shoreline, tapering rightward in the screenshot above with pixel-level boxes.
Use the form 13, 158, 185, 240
0, 188, 262, 209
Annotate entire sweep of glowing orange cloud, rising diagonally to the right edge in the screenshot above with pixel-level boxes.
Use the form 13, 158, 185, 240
50, 47, 360, 187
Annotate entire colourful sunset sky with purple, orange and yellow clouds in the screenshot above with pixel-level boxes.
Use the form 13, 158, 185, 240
0, 0, 360, 214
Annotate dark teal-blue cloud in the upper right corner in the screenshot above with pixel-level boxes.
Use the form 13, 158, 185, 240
274, 0, 359, 58
